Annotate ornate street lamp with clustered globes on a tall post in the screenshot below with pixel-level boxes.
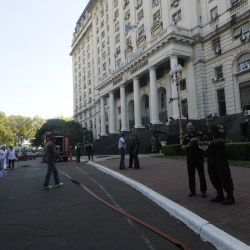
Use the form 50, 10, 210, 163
169, 64, 183, 144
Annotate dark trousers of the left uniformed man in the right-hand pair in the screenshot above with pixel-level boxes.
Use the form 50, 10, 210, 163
187, 158, 207, 194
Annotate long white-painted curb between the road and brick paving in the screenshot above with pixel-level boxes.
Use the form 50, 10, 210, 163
88, 162, 250, 250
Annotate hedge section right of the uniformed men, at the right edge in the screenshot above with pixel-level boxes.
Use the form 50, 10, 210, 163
226, 142, 250, 161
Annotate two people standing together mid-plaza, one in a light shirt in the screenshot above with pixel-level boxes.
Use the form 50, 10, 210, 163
118, 133, 140, 170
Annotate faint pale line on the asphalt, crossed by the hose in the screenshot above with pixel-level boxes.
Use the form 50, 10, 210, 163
76, 167, 156, 250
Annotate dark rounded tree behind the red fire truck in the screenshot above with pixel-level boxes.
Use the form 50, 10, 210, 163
32, 119, 84, 146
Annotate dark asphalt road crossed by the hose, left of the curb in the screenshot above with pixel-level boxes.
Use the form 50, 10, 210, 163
0, 160, 214, 250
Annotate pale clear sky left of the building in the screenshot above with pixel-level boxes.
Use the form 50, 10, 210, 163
0, 0, 88, 118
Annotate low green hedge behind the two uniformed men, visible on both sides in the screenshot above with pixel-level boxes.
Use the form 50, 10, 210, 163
161, 142, 250, 161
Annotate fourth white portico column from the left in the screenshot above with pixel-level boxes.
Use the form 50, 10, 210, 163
133, 78, 144, 128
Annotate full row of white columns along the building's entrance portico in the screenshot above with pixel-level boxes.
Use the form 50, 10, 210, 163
100, 56, 191, 136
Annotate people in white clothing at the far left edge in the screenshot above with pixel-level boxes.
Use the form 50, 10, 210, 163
0, 145, 16, 176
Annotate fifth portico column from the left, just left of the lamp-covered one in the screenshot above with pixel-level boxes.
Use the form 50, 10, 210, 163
149, 67, 161, 124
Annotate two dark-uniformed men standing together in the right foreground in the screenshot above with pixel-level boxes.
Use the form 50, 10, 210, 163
182, 116, 235, 205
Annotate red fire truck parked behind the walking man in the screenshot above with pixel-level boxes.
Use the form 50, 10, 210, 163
44, 131, 70, 161
